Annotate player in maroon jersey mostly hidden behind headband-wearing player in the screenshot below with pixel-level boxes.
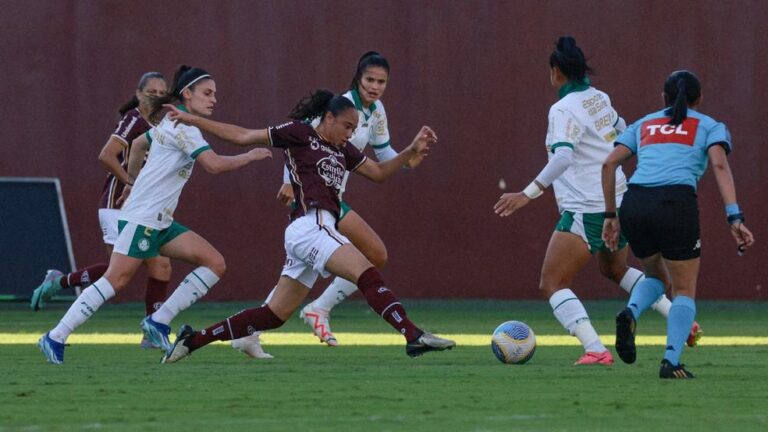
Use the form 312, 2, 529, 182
30, 72, 171, 348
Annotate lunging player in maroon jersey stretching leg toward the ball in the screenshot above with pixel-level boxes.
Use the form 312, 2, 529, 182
163, 90, 456, 363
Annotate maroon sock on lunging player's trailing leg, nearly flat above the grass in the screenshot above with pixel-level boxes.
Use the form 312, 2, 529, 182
184, 306, 285, 352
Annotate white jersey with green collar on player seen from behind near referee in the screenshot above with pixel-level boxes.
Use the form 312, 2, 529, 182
546, 81, 627, 213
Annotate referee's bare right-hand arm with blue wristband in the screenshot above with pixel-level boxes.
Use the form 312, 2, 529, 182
707, 145, 755, 253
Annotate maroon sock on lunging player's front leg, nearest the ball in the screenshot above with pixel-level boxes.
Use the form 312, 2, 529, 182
357, 267, 424, 342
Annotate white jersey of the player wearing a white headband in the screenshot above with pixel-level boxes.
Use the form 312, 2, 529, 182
120, 110, 211, 230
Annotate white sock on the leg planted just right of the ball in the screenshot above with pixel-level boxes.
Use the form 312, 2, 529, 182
549, 288, 606, 352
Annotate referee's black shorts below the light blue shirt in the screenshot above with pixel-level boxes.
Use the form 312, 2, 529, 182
619, 185, 701, 260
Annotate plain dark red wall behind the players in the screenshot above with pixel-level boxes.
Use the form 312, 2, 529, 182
0, 0, 768, 300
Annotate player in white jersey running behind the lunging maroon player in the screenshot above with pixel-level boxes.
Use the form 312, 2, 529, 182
232, 51, 423, 358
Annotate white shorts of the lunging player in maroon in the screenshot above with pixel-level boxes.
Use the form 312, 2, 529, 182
280, 209, 349, 288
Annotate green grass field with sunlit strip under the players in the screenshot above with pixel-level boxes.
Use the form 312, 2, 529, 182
0, 301, 768, 432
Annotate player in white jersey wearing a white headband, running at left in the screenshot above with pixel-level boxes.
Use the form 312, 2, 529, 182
38, 66, 272, 364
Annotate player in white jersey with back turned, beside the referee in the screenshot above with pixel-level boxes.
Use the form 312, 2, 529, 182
494, 36, 700, 365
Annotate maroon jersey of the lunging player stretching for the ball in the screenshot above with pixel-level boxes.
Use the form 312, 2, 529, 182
267, 121, 367, 220
